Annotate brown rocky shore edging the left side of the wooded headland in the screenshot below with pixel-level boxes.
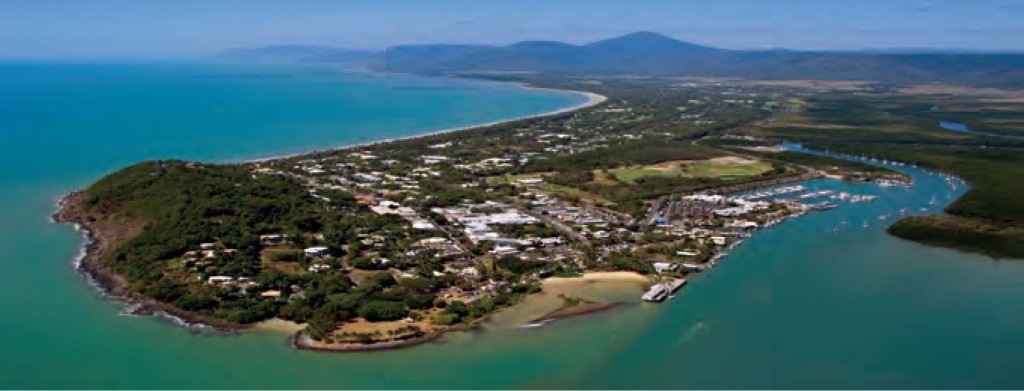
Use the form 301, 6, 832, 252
50, 190, 248, 333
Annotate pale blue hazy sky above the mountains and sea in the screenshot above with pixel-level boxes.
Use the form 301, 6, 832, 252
0, 0, 1024, 59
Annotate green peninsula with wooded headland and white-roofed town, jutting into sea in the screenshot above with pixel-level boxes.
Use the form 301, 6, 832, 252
54, 75, 1019, 351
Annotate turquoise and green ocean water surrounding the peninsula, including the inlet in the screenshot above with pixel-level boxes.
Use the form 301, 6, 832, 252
0, 63, 1024, 388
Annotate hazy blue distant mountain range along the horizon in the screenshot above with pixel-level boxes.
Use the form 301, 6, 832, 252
220, 32, 1024, 87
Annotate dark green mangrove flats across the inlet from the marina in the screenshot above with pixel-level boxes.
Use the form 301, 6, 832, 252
738, 88, 1024, 258
